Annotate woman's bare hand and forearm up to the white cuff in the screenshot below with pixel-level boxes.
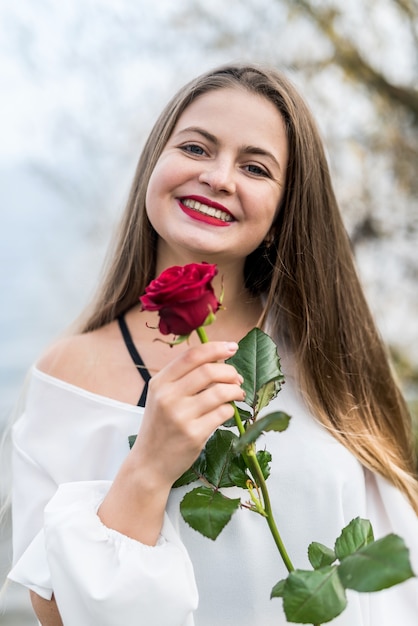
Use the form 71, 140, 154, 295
98, 341, 244, 545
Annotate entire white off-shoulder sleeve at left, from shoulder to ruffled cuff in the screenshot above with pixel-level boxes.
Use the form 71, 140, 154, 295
8, 374, 198, 626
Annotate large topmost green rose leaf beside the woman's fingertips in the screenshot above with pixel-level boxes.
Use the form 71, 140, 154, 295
227, 328, 284, 408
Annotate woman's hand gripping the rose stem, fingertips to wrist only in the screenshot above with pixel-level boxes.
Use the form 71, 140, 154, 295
132, 342, 244, 487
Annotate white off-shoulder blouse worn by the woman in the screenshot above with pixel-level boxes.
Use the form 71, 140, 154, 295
9, 368, 418, 626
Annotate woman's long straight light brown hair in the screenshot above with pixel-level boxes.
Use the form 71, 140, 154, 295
76, 65, 418, 513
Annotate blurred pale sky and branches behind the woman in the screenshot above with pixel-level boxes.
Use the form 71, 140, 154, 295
0, 0, 418, 626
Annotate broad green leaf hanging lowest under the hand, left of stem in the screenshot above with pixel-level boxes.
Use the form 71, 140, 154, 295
180, 487, 241, 539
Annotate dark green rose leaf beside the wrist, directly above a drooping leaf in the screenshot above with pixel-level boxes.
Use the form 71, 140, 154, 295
203, 429, 248, 489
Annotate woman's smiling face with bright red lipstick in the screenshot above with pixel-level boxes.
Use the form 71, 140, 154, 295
146, 88, 288, 267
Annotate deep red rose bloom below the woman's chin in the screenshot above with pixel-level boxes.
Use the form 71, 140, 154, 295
139, 263, 220, 335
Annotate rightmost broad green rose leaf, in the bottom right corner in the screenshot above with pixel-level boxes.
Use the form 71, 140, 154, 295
338, 534, 414, 591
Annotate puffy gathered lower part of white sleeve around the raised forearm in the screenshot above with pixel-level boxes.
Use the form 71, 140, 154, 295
45, 481, 197, 626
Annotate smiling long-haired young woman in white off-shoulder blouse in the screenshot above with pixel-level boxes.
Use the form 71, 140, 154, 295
6, 65, 418, 626
